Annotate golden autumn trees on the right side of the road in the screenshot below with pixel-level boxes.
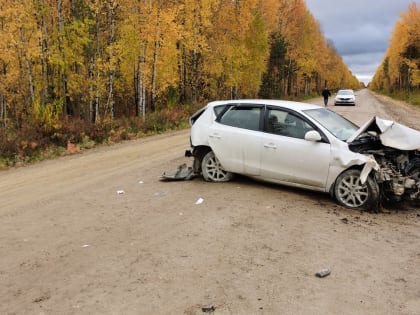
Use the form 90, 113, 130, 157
370, 2, 420, 107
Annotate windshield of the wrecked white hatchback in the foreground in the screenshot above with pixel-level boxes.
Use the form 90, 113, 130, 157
304, 108, 359, 141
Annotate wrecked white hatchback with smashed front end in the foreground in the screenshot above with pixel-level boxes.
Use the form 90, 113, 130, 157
186, 100, 420, 210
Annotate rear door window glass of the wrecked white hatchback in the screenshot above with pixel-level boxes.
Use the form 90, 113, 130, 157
219, 106, 261, 131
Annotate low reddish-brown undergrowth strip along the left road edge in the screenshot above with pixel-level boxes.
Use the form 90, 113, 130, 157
0, 106, 193, 170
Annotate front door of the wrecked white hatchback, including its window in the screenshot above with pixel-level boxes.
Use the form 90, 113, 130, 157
261, 108, 331, 190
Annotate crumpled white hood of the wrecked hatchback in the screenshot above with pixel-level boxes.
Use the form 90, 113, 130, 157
347, 116, 420, 150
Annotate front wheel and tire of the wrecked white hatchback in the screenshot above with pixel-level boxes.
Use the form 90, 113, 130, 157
334, 169, 379, 212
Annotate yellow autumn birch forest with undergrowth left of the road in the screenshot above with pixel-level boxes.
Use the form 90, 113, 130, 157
0, 0, 404, 168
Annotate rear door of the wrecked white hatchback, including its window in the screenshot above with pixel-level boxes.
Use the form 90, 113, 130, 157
209, 104, 262, 176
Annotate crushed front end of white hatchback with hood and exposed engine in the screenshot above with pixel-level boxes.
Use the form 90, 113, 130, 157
347, 117, 420, 202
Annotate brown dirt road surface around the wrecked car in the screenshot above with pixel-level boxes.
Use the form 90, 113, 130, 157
0, 90, 420, 315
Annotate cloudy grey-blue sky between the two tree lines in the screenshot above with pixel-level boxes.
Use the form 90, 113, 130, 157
306, 0, 420, 83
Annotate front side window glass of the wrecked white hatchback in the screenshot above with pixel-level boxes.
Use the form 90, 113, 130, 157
266, 109, 313, 139
